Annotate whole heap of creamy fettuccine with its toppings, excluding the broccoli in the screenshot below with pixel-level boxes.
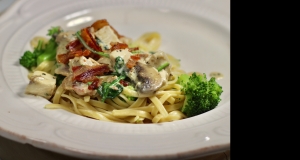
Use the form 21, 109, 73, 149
22, 20, 190, 123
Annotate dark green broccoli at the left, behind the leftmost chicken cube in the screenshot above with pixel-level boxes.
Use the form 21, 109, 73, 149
19, 27, 61, 70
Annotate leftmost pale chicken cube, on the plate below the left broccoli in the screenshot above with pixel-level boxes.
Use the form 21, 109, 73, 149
25, 71, 56, 99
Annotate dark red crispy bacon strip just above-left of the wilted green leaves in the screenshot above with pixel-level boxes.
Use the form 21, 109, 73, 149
72, 64, 110, 83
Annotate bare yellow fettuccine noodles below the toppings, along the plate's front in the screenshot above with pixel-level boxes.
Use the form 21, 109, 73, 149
45, 72, 185, 123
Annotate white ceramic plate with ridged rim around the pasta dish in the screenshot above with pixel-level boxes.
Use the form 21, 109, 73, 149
0, 0, 230, 159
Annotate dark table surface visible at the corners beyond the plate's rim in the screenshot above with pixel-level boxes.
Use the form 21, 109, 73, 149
0, 0, 230, 160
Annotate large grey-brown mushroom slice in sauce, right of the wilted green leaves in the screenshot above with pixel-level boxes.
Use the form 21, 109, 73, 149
128, 62, 164, 96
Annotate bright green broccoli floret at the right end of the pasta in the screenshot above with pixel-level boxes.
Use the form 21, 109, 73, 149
177, 72, 223, 117
